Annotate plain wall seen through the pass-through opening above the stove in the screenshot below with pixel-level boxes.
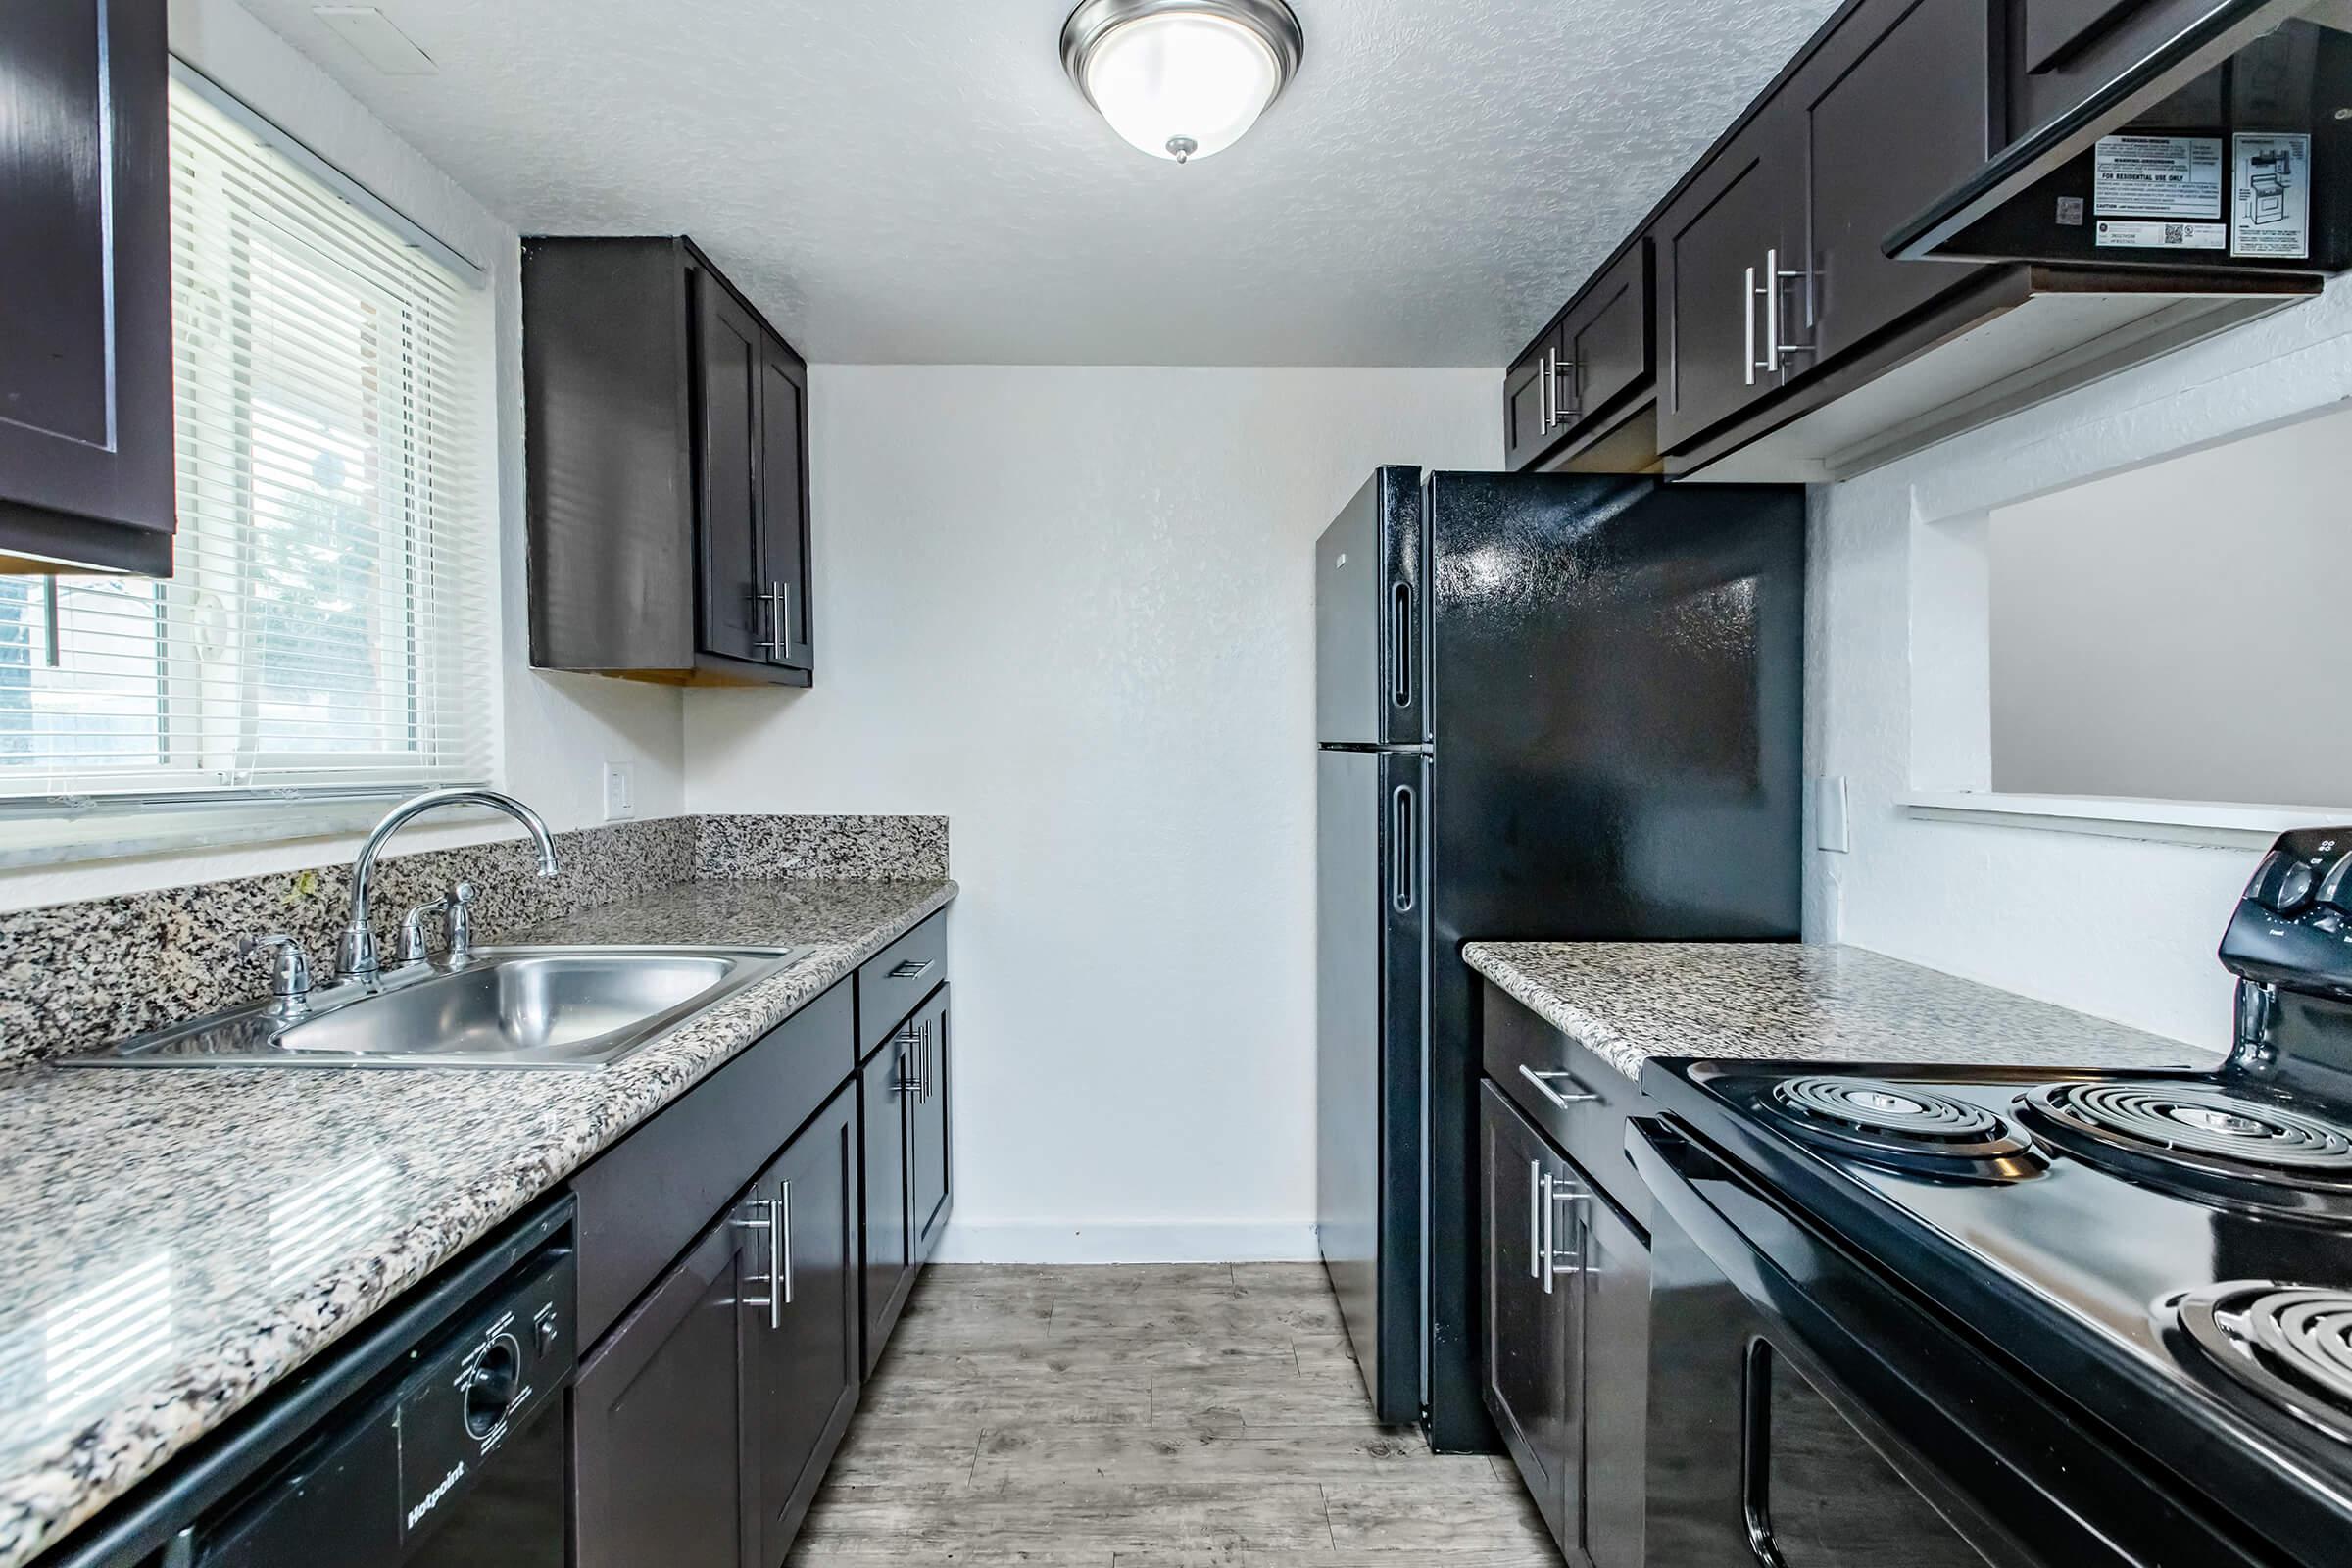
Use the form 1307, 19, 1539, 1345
1987, 412, 2352, 808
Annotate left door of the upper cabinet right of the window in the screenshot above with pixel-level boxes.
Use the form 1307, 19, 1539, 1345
694, 272, 769, 662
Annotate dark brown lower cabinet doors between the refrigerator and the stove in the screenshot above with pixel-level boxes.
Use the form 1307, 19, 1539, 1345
1480, 1084, 1648, 1568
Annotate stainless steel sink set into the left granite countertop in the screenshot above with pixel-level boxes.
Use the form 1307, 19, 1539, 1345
59, 945, 809, 1069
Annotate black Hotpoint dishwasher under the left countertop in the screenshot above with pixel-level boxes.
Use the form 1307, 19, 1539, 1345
43, 1199, 576, 1568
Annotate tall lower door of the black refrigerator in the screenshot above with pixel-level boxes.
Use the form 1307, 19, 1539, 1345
1315, 750, 1428, 1425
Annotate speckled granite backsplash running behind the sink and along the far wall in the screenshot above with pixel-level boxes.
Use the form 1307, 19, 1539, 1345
0, 815, 948, 1062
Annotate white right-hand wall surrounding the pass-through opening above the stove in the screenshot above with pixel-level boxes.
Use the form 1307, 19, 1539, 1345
1806, 279, 2352, 1049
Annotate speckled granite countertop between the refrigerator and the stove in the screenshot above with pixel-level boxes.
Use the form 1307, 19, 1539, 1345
1463, 943, 2221, 1079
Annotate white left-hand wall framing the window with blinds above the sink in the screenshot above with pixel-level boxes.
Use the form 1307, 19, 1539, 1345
0, 0, 684, 909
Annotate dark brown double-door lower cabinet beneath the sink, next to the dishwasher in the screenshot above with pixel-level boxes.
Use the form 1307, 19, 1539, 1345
571, 1089, 863, 1568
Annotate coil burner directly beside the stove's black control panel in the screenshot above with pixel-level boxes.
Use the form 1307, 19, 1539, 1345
2018, 1079, 2352, 1220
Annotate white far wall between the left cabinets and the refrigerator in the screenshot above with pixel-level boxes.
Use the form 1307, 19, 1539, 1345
687, 365, 1500, 1260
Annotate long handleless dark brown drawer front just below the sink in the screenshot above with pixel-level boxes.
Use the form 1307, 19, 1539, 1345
571, 983, 857, 1345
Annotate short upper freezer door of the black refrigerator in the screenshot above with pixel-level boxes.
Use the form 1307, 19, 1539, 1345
1315, 467, 1428, 745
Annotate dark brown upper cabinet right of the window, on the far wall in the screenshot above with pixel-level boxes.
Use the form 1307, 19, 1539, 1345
522, 237, 816, 686
